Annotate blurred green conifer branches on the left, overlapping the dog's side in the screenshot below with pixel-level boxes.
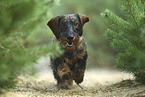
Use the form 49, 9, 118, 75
0, 0, 61, 90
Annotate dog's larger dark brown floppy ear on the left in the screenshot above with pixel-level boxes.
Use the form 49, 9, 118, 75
47, 15, 61, 39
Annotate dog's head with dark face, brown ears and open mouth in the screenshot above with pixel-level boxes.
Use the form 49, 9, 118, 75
47, 14, 89, 51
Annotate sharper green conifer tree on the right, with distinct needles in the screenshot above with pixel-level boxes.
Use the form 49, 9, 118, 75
101, 0, 145, 83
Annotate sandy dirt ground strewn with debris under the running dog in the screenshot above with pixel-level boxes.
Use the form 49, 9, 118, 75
2, 59, 145, 97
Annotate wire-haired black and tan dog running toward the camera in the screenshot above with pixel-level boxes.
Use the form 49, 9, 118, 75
47, 14, 89, 89
